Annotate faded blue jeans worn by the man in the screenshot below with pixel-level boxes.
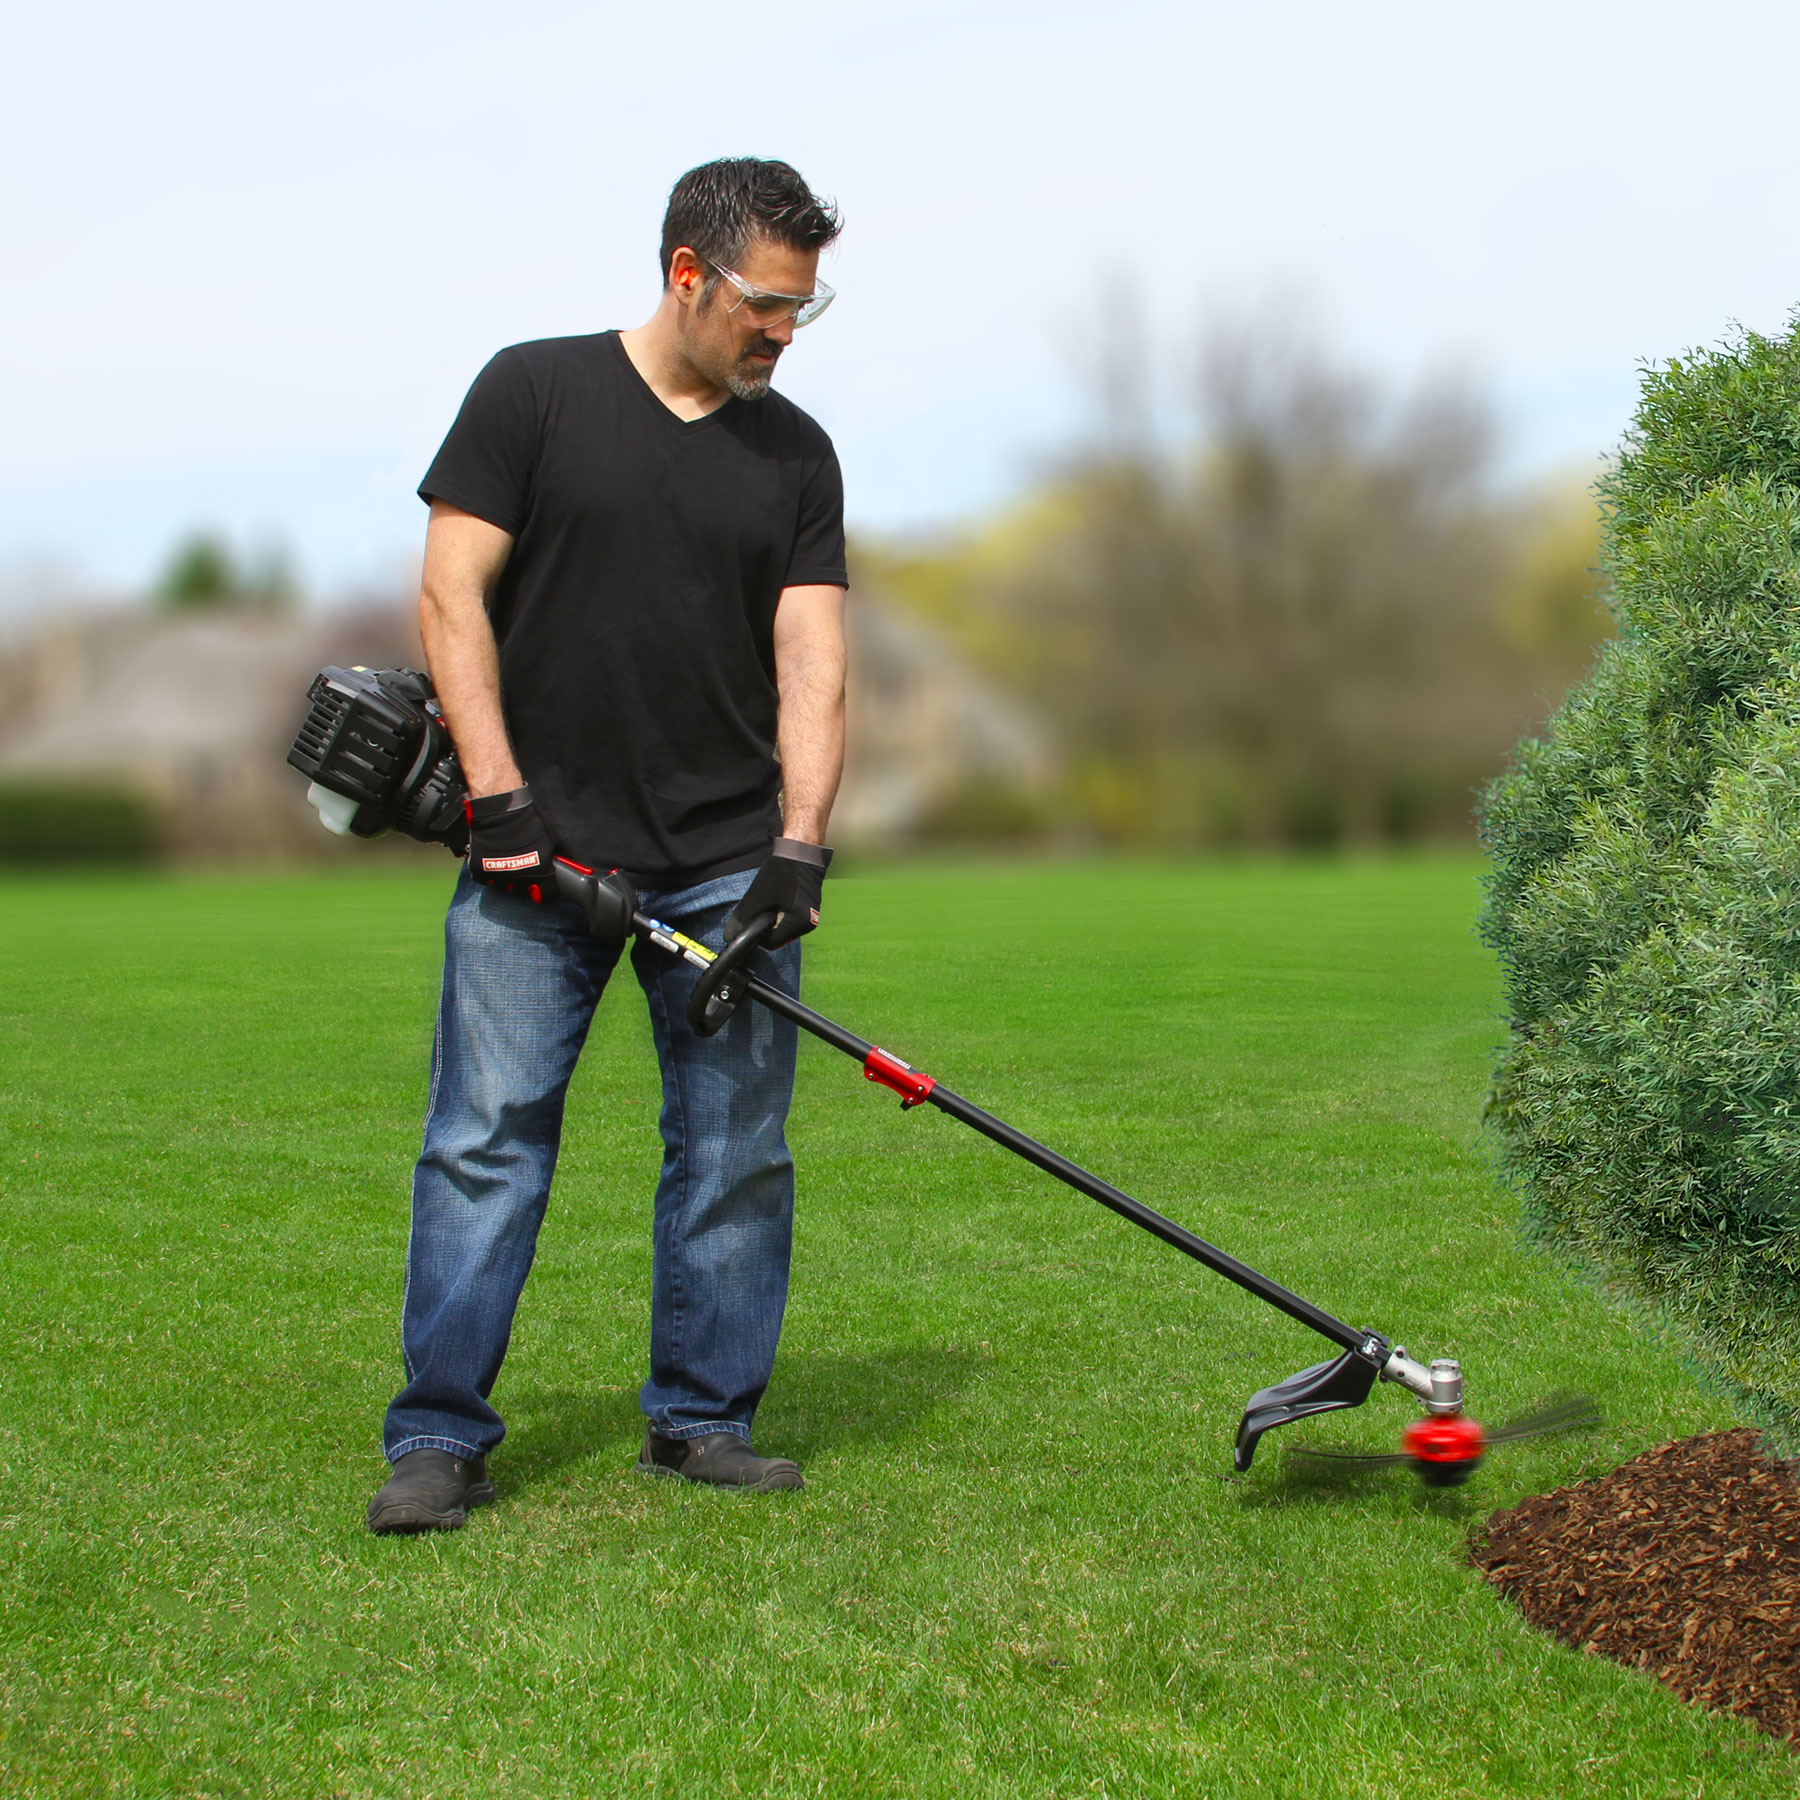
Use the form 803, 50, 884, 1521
382, 869, 799, 1462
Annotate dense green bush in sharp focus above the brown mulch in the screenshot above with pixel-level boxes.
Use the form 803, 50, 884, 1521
1481, 317, 1800, 1453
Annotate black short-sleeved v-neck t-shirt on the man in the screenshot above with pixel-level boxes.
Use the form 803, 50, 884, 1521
419, 331, 848, 887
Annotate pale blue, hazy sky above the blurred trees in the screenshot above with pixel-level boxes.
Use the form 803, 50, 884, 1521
0, 0, 1800, 614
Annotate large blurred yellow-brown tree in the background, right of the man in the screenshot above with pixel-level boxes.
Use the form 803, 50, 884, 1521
859, 328, 1607, 846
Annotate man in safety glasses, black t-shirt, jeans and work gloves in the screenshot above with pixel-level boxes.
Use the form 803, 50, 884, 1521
369, 158, 846, 1532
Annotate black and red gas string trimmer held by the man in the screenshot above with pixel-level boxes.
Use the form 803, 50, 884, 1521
288, 668, 1597, 1487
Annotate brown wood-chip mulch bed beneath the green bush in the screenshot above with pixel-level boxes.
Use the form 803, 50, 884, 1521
1471, 1431, 1800, 1744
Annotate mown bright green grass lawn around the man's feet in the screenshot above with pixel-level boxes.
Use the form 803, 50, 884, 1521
0, 859, 1796, 1800
